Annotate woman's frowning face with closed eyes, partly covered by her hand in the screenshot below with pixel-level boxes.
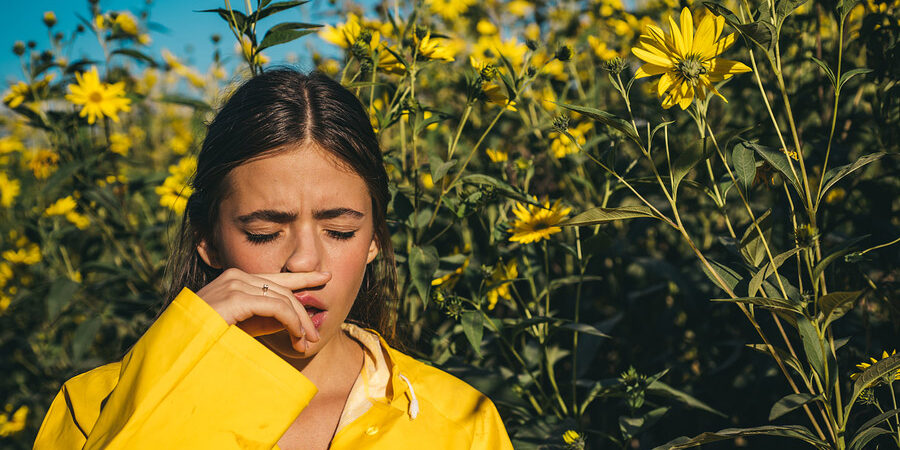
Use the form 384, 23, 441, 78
201, 145, 378, 358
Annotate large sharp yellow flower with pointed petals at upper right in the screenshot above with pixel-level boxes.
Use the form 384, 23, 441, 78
631, 8, 750, 109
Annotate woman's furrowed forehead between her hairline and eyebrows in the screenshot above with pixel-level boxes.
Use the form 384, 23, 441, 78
222, 146, 372, 214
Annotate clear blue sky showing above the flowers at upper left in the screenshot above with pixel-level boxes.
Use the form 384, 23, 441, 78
0, 0, 350, 83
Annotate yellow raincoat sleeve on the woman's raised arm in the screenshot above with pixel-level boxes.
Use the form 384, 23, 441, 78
34, 288, 317, 450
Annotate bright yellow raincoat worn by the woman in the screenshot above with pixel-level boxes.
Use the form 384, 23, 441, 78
34, 288, 512, 450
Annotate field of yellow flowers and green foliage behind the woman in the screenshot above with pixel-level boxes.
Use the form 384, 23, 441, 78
0, 0, 900, 449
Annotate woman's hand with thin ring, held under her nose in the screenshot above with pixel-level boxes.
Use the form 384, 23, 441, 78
197, 268, 331, 352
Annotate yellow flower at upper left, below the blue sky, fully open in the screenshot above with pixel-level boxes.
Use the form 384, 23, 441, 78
66, 66, 131, 124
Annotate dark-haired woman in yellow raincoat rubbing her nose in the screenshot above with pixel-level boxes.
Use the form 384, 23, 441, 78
35, 69, 511, 450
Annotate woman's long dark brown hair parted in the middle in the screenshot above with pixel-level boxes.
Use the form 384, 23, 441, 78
166, 68, 397, 343
